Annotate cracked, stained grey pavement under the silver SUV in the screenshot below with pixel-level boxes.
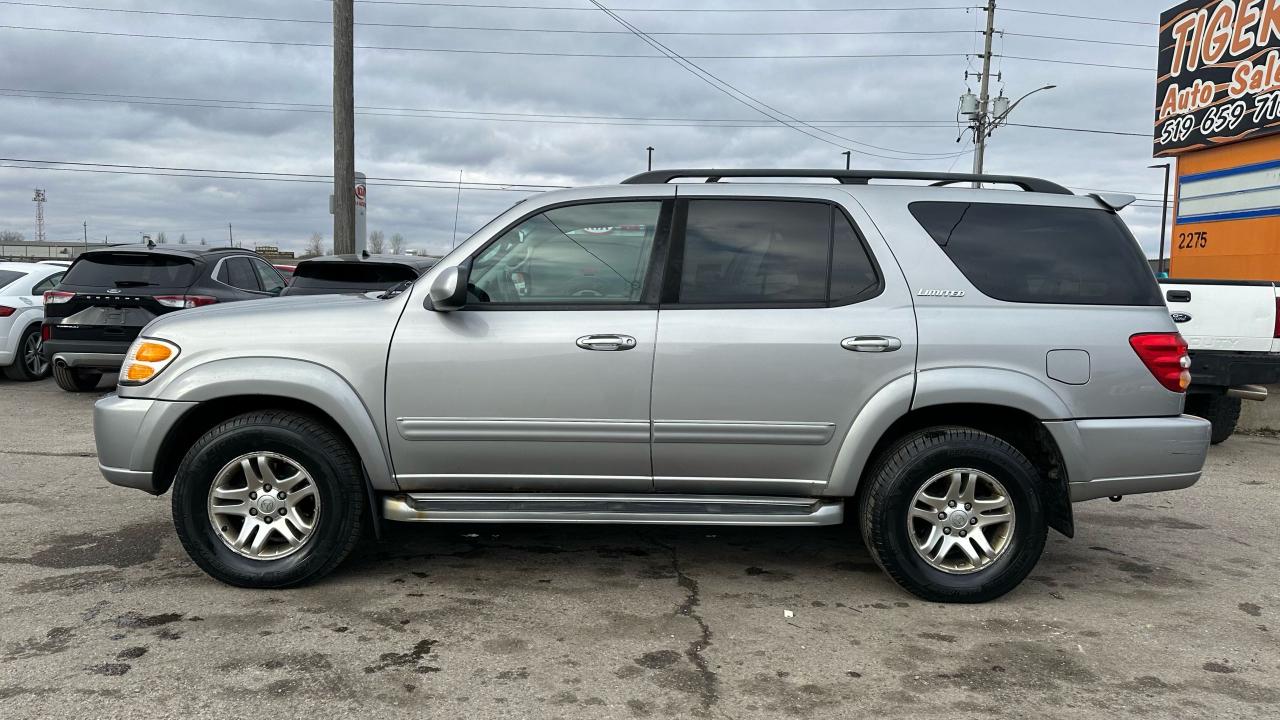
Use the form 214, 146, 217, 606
0, 380, 1280, 720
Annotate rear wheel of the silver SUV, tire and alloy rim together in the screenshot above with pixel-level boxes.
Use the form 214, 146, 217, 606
859, 427, 1047, 602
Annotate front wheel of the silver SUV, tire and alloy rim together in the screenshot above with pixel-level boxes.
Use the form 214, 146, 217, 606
173, 410, 366, 588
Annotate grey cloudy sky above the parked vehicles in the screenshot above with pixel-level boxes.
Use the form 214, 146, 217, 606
0, 0, 1172, 255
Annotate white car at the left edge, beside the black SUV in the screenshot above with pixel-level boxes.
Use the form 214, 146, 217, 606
0, 263, 67, 380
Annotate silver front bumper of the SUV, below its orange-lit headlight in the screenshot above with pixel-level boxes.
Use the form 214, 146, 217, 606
93, 395, 196, 495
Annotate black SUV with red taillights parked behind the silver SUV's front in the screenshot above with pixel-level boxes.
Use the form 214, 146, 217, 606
44, 245, 284, 392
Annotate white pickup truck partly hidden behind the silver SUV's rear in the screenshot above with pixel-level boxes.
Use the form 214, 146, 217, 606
1160, 279, 1280, 445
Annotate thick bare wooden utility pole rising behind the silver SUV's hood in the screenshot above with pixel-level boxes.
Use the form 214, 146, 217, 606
333, 0, 356, 255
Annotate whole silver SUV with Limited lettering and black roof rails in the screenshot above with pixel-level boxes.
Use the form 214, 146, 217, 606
95, 169, 1210, 602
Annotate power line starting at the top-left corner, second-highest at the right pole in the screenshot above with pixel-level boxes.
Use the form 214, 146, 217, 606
0, 0, 973, 37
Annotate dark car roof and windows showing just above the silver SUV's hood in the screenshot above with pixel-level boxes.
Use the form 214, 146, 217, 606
280, 254, 439, 296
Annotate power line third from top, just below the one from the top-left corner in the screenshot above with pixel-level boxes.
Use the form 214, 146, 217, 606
0, 24, 965, 60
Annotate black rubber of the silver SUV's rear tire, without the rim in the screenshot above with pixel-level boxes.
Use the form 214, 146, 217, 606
859, 427, 1047, 602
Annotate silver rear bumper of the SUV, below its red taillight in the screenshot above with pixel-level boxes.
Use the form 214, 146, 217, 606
1044, 415, 1210, 502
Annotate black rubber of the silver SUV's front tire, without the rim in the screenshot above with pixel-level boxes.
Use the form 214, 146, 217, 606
173, 410, 366, 588
